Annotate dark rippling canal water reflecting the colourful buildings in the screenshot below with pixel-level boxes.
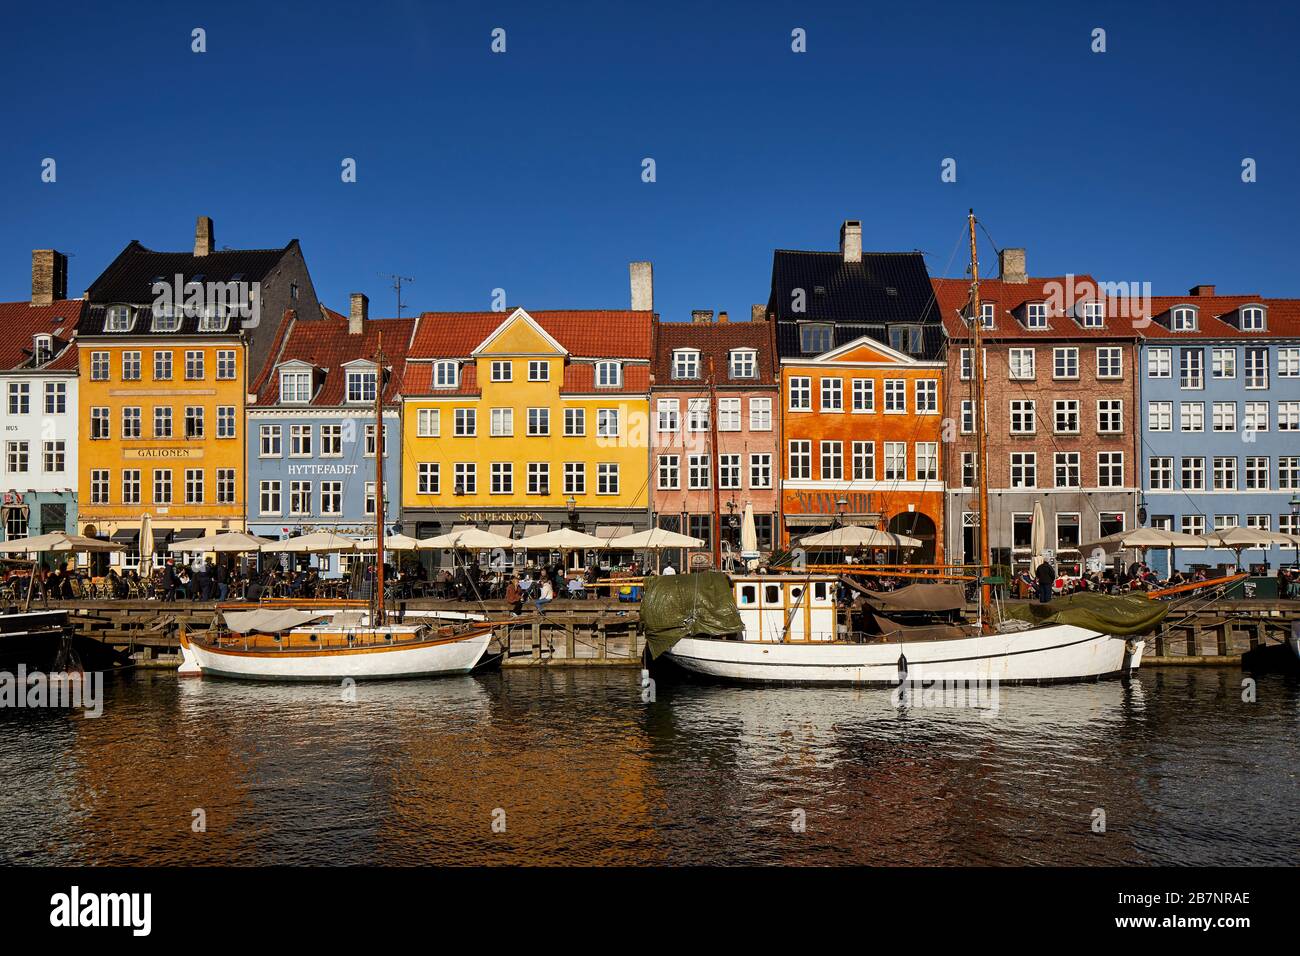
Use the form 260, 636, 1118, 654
0, 667, 1300, 865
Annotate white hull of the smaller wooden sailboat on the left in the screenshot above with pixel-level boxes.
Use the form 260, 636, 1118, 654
181, 627, 493, 680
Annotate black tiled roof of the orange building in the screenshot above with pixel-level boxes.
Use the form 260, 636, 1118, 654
767, 248, 944, 359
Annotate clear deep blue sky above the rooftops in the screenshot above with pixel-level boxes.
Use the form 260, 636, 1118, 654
0, 0, 1300, 319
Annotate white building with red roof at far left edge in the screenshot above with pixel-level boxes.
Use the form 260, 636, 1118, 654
0, 248, 85, 541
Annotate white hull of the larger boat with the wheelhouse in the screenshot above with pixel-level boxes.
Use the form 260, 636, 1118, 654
667, 624, 1144, 685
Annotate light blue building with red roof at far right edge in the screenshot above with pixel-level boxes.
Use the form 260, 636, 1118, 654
1139, 286, 1300, 571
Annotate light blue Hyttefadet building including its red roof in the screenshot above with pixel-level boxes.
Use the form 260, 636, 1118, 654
246, 293, 405, 576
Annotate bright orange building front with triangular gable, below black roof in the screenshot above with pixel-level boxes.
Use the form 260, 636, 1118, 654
781, 336, 945, 563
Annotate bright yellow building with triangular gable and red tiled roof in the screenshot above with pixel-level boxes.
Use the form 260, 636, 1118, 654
402, 308, 654, 564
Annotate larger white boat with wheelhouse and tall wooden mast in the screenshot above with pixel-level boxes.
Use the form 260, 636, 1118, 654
665, 212, 1145, 684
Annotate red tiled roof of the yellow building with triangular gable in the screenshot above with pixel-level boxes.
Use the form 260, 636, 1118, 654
410, 308, 654, 359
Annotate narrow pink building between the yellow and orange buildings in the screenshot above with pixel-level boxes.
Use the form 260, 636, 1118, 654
650, 307, 781, 554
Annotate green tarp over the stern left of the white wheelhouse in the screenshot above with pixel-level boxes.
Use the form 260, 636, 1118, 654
641, 571, 745, 658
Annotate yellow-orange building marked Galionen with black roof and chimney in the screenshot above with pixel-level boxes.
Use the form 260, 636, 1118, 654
78, 217, 319, 567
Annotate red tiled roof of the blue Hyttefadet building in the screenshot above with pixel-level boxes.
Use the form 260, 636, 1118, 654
256, 310, 416, 407
